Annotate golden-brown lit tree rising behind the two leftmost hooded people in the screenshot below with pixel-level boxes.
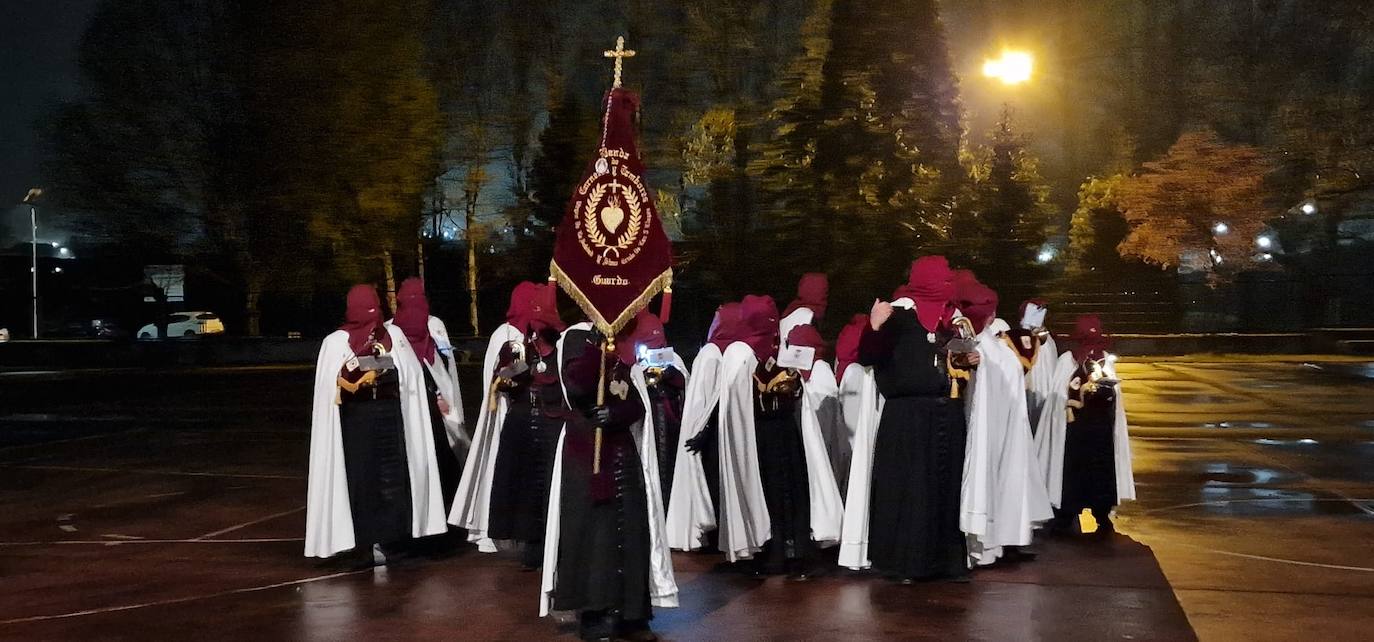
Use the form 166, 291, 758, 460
254, 0, 440, 306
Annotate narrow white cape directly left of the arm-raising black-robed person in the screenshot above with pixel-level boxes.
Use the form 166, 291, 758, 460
840, 363, 883, 571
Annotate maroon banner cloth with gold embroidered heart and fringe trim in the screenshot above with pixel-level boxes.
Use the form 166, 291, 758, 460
550, 88, 673, 337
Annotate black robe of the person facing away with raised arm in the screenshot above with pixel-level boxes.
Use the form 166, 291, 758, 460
859, 309, 967, 579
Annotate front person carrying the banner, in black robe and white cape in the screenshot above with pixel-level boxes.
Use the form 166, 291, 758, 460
540, 311, 677, 639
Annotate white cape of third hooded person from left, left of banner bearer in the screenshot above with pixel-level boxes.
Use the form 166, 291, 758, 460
448, 323, 525, 553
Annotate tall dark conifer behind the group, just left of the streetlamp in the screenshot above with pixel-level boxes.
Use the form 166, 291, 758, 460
750, 0, 962, 318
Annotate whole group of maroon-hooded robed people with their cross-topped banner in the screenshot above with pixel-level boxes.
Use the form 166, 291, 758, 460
305, 39, 1135, 639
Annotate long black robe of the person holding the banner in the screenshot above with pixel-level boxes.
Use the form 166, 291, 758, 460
545, 330, 653, 621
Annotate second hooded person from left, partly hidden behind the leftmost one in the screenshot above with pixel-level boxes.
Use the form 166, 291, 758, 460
390, 276, 471, 511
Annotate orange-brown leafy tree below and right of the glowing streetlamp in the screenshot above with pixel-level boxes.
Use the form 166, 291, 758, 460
1117, 131, 1274, 285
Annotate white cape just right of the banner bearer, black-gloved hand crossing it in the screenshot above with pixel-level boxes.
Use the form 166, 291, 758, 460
666, 344, 721, 550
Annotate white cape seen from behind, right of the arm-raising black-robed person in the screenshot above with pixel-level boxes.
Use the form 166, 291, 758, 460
959, 319, 1054, 565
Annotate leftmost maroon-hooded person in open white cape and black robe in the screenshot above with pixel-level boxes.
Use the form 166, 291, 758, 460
305, 286, 447, 565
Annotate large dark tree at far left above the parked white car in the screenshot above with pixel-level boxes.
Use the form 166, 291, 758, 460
49, 0, 302, 334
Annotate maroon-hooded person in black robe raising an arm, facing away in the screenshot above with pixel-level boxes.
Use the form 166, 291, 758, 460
842, 257, 973, 583
